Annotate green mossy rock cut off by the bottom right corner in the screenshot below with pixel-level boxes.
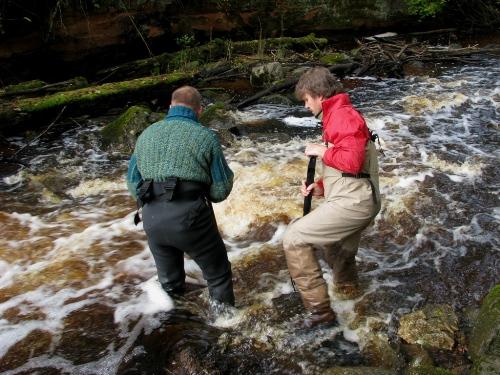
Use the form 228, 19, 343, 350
469, 285, 500, 375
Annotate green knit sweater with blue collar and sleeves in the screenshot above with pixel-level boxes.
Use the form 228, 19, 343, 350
127, 106, 233, 202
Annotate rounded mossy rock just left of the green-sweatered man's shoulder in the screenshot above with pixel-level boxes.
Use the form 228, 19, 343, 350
101, 106, 161, 153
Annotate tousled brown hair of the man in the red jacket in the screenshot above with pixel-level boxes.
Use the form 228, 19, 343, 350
295, 67, 344, 100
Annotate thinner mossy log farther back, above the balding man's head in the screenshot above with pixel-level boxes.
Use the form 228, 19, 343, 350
97, 34, 328, 82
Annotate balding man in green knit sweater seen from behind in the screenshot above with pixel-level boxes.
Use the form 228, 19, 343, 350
127, 86, 234, 305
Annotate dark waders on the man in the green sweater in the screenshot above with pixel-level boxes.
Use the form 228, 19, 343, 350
142, 180, 234, 305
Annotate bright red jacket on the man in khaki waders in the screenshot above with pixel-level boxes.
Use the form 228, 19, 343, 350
321, 94, 370, 174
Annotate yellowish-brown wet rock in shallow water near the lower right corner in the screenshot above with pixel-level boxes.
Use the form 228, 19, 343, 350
398, 305, 458, 350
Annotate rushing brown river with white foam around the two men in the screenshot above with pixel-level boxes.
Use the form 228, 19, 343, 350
0, 57, 500, 374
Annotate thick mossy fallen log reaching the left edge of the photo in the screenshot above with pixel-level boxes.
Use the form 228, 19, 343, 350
0, 72, 192, 134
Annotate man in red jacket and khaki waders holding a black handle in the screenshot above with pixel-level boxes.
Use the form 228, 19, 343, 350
283, 68, 380, 328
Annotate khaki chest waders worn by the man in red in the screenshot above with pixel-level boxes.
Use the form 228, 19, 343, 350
283, 175, 380, 311
